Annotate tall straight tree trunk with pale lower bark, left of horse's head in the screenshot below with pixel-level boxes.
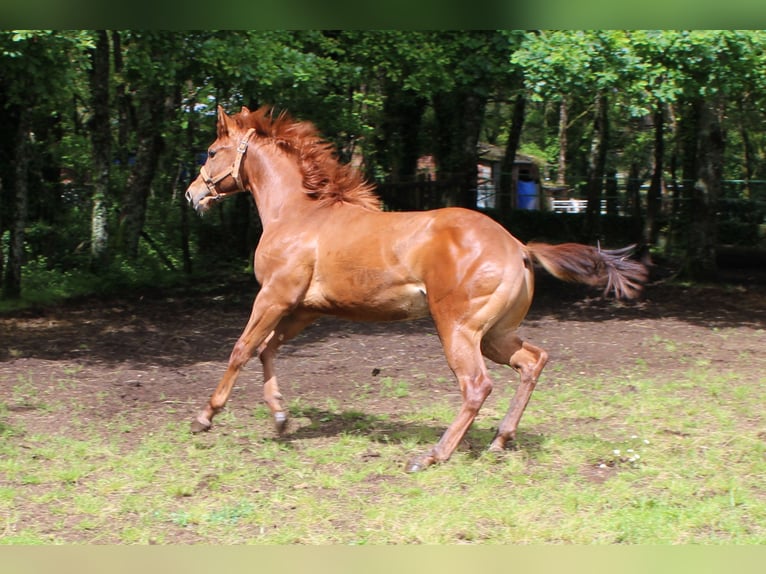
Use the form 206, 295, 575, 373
90, 30, 112, 270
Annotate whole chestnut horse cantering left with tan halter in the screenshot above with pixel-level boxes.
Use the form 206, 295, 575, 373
186, 107, 647, 472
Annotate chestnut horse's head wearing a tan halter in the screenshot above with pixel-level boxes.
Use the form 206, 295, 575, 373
186, 106, 255, 213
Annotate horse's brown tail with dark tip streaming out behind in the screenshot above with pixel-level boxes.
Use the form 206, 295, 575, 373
526, 243, 649, 299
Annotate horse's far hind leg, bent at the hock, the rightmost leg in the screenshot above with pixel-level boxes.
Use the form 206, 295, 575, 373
481, 332, 548, 452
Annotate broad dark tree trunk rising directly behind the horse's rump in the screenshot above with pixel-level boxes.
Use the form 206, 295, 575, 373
433, 91, 487, 209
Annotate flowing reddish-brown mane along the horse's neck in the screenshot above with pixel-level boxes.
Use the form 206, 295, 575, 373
232, 106, 381, 211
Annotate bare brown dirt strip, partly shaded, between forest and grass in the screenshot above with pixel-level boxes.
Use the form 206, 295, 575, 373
0, 270, 766, 446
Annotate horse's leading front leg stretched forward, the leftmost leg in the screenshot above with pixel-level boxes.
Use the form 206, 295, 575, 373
191, 289, 291, 433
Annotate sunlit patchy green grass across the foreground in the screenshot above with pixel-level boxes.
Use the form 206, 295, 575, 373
0, 364, 766, 545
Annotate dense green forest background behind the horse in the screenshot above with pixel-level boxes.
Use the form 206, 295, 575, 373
0, 30, 766, 302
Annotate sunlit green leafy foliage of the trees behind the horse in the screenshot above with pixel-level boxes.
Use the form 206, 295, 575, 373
0, 30, 766, 306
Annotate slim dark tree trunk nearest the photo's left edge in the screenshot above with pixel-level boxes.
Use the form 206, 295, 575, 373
3, 109, 30, 299
